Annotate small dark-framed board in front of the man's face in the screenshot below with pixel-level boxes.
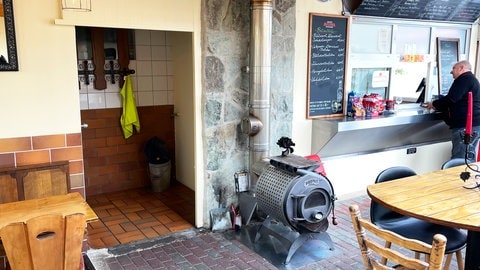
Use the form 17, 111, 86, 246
437, 38, 460, 95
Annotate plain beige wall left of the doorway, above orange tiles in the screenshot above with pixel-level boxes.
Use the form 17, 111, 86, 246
0, 0, 80, 138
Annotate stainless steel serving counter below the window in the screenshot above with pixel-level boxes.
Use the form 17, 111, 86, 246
312, 104, 450, 158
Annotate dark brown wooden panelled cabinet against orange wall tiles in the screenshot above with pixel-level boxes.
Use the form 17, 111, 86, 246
0, 161, 70, 203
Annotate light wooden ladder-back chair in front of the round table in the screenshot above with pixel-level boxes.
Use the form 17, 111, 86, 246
349, 205, 447, 270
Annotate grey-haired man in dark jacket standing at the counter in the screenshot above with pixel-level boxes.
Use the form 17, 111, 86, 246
431, 60, 480, 161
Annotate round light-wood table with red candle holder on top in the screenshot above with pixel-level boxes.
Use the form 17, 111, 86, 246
367, 163, 480, 269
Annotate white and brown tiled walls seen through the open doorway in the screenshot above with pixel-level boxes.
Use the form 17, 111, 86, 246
76, 27, 195, 247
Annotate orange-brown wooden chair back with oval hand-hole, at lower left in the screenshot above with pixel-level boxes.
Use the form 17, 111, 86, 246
0, 214, 86, 270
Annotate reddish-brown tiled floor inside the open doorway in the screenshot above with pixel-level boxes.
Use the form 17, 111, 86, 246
87, 183, 195, 249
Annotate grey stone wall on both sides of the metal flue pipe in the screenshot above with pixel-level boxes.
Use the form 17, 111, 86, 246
201, 0, 295, 224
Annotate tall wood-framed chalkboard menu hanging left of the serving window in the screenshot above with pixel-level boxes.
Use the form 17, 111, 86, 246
307, 13, 348, 118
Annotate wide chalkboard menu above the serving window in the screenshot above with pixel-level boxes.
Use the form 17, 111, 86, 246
353, 0, 480, 23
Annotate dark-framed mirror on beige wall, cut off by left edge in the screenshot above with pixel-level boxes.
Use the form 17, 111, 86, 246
0, 0, 18, 71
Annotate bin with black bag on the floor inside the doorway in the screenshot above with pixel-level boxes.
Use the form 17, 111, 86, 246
144, 136, 172, 192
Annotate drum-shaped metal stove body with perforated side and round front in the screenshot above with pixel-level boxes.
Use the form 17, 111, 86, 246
256, 166, 335, 232
